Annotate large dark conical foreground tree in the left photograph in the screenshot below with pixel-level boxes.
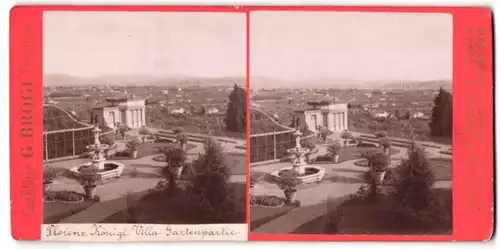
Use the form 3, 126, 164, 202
189, 138, 241, 223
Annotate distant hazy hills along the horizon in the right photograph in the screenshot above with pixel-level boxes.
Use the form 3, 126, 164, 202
250, 77, 452, 90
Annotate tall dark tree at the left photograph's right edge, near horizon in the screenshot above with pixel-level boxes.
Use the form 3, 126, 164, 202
226, 84, 247, 132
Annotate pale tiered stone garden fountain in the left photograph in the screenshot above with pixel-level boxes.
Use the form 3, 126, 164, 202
71, 126, 125, 180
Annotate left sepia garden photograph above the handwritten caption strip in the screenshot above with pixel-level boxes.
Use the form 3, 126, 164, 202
43, 11, 248, 226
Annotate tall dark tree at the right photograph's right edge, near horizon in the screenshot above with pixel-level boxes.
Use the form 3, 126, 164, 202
429, 88, 453, 138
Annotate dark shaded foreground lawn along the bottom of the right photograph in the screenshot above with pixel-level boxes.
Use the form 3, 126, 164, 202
292, 189, 453, 235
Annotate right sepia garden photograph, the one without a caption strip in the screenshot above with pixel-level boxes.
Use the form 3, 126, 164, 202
249, 11, 453, 235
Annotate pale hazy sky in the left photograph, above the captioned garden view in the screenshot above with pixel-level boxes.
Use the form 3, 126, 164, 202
43, 11, 246, 77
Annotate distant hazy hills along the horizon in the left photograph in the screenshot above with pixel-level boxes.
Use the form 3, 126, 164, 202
43, 74, 246, 87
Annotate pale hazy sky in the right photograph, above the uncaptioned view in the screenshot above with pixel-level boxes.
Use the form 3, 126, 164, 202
250, 12, 453, 81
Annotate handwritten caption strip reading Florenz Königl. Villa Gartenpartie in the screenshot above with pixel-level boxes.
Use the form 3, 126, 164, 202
42, 224, 246, 241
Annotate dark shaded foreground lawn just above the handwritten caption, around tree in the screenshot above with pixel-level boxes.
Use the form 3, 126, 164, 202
100, 183, 246, 224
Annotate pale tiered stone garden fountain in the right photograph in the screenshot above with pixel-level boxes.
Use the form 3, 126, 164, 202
271, 130, 326, 184
